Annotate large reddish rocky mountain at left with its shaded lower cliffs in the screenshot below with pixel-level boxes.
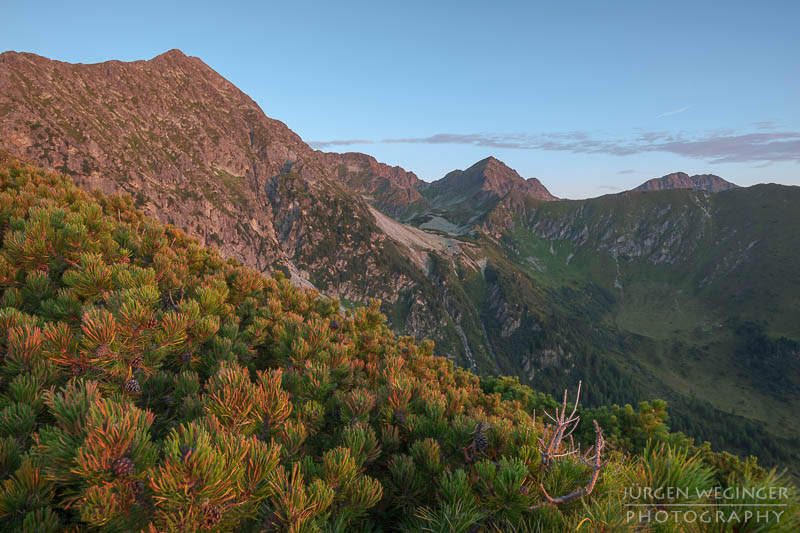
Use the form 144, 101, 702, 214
0, 50, 476, 364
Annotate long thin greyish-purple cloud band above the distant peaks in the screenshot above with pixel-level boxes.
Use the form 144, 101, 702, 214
312, 129, 800, 163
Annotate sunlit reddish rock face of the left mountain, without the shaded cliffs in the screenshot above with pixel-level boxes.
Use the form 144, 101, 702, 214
0, 50, 300, 269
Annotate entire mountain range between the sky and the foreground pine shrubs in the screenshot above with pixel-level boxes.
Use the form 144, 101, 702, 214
0, 50, 800, 464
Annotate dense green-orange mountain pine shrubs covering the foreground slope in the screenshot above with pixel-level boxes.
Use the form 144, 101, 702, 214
0, 153, 800, 533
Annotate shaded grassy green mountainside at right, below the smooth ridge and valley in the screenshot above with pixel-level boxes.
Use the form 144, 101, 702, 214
462, 185, 800, 466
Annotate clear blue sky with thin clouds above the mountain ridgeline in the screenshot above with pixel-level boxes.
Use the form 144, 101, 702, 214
0, 0, 800, 198
